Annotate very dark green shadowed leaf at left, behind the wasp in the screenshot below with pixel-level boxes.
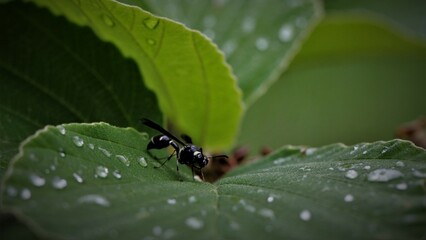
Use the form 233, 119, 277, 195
0, 1, 161, 177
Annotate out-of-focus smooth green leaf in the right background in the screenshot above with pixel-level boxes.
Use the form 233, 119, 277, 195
238, 14, 426, 152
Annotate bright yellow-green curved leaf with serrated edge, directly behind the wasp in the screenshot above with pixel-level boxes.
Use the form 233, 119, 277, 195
30, 0, 242, 149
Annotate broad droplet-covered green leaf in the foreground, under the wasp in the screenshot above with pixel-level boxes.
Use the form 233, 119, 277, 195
1, 123, 426, 239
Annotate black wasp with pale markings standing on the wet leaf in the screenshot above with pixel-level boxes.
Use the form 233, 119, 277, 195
141, 118, 228, 180
